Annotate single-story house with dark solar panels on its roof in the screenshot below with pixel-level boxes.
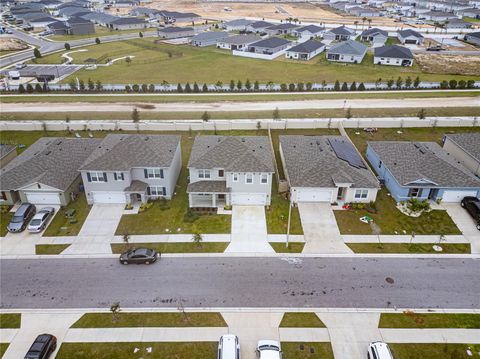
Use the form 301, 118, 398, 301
280, 136, 380, 204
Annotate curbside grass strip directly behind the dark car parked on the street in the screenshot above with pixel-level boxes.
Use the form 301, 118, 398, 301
111, 242, 229, 254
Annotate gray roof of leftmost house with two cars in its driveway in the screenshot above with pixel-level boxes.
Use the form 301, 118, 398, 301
0, 137, 101, 191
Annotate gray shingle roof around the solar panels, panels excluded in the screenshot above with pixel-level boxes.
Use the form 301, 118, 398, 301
280, 136, 379, 188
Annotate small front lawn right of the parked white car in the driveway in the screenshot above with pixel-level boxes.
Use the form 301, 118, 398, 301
43, 193, 91, 236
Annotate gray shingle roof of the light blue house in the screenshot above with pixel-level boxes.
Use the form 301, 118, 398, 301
368, 141, 480, 188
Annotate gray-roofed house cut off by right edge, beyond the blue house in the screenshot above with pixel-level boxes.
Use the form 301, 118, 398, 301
443, 132, 480, 178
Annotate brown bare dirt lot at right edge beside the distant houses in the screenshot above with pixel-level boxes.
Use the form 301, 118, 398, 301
415, 54, 480, 76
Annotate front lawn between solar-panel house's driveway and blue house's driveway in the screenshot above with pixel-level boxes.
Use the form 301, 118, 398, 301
334, 188, 461, 235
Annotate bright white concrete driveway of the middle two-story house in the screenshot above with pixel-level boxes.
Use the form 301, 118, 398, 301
225, 206, 275, 253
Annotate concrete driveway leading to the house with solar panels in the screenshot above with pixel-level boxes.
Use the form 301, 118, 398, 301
298, 203, 352, 254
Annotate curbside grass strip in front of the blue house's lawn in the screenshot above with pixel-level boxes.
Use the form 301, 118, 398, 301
346, 243, 471, 254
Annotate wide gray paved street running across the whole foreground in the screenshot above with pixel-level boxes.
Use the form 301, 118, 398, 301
0, 257, 480, 309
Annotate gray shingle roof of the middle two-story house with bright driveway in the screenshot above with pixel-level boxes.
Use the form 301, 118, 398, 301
188, 136, 275, 173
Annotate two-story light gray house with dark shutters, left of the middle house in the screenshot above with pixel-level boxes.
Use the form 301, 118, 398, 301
80, 134, 182, 204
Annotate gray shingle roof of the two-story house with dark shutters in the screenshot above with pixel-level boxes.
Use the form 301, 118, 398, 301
80, 134, 180, 171
